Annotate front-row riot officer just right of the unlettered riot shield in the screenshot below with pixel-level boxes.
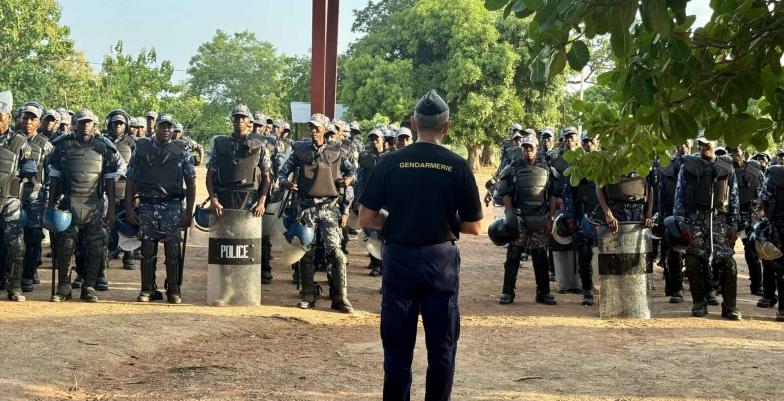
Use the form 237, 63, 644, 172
674, 134, 741, 320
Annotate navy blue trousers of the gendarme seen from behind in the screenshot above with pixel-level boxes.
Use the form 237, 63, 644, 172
381, 242, 460, 401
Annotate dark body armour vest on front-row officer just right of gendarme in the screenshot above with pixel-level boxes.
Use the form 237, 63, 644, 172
512, 161, 550, 232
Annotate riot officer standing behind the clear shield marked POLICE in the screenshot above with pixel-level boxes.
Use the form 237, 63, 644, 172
207, 104, 272, 302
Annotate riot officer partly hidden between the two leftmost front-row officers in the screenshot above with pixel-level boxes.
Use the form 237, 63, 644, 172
22, 106, 54, 292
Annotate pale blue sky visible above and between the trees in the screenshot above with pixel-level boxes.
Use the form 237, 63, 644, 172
59, 0, 711, 81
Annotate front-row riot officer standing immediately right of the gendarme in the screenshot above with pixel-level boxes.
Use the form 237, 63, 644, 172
498, 133, 558, 305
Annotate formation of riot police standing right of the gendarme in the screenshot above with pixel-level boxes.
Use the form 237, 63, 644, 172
485, 124, 784, 321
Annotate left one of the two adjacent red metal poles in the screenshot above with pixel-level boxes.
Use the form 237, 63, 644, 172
310, 0, 327, 114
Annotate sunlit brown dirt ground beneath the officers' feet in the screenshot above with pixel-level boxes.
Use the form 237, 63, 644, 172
0, 167, 784, 401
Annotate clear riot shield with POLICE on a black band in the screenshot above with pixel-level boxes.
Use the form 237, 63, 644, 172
207, 209, 261, 306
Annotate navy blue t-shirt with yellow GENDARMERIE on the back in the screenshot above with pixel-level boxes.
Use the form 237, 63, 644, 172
360, 142, 482, 245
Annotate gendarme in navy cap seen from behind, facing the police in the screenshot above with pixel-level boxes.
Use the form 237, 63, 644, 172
359, 90, 482, 400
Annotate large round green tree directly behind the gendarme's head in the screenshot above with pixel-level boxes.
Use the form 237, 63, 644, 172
340, 0, 563, 169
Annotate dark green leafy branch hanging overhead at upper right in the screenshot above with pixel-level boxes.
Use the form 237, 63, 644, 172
485, 0, 784, 184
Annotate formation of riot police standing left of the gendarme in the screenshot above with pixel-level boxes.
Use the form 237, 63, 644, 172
0, 92, 412, 313
